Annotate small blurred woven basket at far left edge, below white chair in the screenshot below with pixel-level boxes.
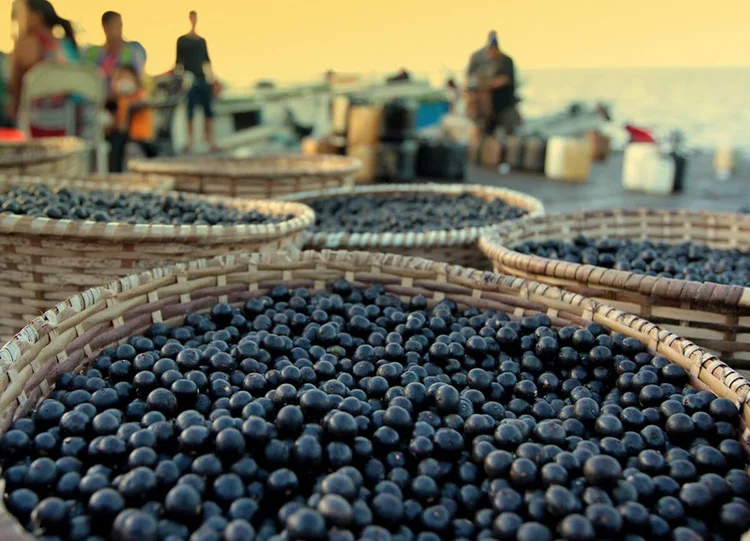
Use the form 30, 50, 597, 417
0, 137, 90, 177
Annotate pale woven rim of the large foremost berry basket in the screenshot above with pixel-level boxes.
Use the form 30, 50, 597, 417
0, 250, 750, 410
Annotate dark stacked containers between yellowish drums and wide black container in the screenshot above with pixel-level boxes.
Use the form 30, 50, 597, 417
378, 99, 419, 182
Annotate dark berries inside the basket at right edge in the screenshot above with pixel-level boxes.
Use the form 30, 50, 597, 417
513, 235, 750, 287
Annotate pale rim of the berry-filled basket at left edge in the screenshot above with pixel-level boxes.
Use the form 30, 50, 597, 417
0, 177, 315, 241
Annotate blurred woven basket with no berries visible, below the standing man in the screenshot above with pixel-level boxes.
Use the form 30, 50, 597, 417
128, 155, 361, 199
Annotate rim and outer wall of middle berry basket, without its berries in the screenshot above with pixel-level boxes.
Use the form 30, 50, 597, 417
281, 184, 544, 269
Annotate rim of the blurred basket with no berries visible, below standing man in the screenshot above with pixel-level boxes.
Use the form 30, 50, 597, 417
128, 154, 362, 180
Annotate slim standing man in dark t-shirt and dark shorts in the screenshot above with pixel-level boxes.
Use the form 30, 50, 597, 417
176, 11, 218, 152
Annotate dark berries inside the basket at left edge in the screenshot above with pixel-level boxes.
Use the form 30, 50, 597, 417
0, 184, 292, 226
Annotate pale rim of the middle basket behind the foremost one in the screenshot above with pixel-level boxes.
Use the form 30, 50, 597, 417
276, 182, 544, 249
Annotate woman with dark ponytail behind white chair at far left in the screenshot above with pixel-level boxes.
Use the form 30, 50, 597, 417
10, 0, 83, 137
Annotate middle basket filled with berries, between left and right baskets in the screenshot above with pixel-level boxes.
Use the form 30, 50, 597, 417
284, 184, 544, 268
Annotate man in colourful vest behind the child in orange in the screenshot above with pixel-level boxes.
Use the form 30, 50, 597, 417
84, 11, 146, 103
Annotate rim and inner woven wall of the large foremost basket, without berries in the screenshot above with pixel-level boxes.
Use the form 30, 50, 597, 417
0, 252, 750, 541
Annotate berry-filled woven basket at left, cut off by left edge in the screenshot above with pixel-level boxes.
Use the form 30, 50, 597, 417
0, 177, 314, 341
